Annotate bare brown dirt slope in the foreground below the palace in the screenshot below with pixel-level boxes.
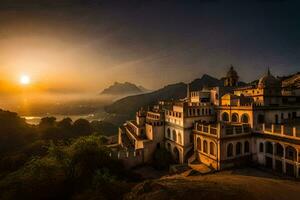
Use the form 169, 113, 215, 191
125, 168, 300, 200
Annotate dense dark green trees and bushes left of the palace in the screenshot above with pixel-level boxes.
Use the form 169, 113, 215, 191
0, 110, 133, 200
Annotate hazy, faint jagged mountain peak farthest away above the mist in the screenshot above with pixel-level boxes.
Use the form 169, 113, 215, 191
100, 82, 148, 95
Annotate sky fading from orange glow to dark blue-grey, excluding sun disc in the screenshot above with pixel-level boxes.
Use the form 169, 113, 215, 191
0, 0, 300, 95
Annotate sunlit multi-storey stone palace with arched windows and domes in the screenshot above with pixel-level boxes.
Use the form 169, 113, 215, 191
118, 66, 300, 178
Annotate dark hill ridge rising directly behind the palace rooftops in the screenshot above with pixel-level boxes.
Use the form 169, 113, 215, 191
105, 74, 223, 115
